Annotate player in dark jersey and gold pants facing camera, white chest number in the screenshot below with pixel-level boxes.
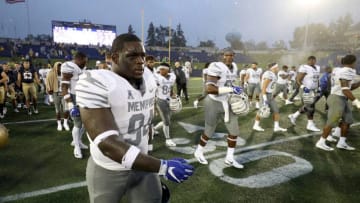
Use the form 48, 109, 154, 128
17, 60, 41, 115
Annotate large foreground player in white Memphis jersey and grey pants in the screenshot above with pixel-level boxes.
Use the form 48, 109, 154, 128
76, 34, 193, 203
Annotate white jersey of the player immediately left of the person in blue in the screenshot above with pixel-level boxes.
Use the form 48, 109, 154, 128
299, 65, 320, 90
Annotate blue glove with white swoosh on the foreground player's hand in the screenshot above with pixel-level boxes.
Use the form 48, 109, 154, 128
159, 158, 194, 183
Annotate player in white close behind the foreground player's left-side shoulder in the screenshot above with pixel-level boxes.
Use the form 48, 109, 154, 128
61, 52, 88, 159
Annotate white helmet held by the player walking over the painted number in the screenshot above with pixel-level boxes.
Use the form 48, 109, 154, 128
229, 93, 250, 116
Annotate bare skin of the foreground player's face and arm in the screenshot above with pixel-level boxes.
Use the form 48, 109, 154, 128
80, 42, 160, 172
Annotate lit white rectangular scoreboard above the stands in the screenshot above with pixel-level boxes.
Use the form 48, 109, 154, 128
51, 21, 116, 46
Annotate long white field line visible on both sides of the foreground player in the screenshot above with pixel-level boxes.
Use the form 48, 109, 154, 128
0, 122, 360, 202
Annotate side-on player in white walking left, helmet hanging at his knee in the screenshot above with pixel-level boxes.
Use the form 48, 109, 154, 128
253, 63, 287, 132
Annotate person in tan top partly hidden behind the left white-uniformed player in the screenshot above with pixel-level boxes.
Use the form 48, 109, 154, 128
45, 62, 70, 131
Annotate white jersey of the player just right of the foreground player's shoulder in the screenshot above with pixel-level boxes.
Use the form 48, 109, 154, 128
154, 73, 176, 100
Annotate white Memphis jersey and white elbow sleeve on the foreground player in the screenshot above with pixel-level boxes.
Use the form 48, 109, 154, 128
76, 69, 156, 170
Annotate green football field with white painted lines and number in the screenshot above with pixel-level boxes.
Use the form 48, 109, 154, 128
0, 78, 360, 203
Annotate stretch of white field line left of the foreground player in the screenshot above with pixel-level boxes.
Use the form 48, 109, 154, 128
0, 181, 86, 202
